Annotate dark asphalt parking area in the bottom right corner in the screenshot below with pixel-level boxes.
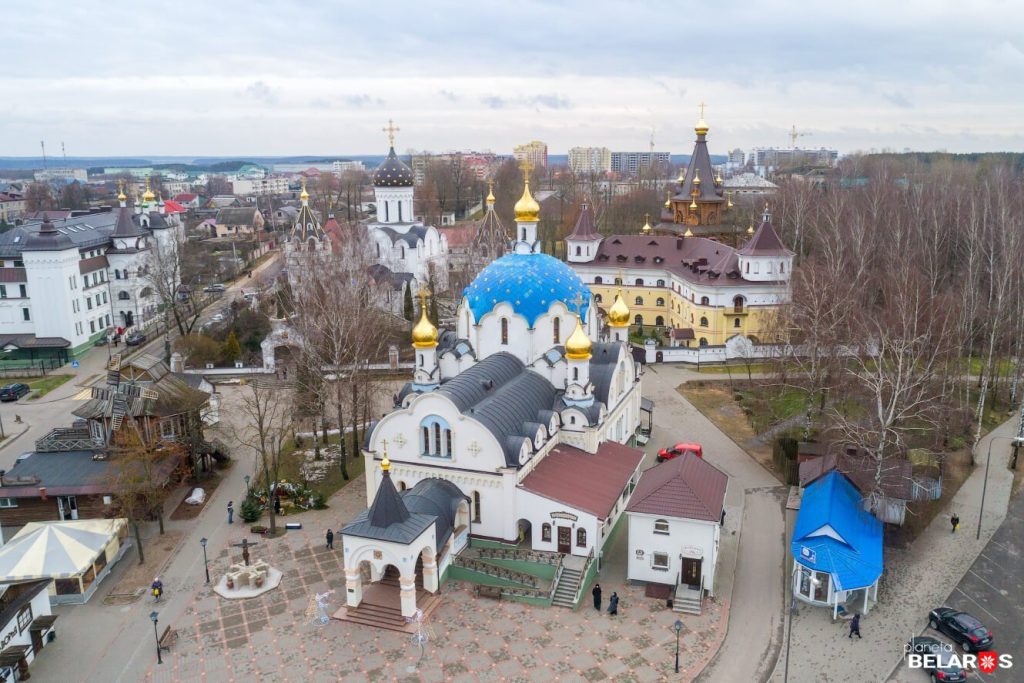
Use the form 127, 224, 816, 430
890, 494, 1024, 683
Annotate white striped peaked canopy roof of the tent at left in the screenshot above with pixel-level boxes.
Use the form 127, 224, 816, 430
0, 518, 127, 581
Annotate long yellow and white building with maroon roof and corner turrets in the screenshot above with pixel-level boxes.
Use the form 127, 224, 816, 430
566, 198, 794, 346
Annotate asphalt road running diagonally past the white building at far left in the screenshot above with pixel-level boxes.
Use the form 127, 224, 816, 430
0, 252, 284, 470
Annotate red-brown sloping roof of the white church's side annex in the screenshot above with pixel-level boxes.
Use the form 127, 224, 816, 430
519, 441, 643, 519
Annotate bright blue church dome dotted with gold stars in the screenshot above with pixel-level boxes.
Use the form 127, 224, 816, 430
463, 254, 590, 327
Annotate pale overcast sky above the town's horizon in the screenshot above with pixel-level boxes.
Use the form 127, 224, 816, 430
0, 0, 1024, 156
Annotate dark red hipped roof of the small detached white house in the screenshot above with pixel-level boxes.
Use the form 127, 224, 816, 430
626, 452, 729, 522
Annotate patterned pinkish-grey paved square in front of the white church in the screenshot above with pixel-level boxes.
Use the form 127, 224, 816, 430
140, 478, 727, 681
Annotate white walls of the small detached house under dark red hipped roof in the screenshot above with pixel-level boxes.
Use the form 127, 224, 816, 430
627, 512, 722, 596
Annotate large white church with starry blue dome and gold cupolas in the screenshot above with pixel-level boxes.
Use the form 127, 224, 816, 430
341, 171, 643, 617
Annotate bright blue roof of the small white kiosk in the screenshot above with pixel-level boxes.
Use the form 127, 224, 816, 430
790, 471, 883, 591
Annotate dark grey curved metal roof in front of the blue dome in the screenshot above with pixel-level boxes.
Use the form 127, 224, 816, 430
437, 352, 558, 467
